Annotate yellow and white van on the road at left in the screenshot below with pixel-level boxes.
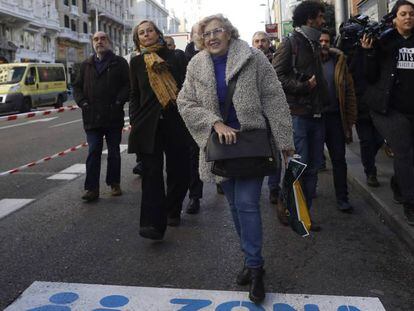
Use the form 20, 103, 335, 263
0, 63, 67, 113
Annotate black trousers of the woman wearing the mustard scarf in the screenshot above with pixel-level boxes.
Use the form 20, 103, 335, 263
140, 119, 190, 232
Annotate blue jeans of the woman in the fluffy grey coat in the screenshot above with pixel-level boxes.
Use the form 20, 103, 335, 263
221, 177, 264, 268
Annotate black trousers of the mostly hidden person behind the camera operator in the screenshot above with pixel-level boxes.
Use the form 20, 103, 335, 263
355, 118, 384, 176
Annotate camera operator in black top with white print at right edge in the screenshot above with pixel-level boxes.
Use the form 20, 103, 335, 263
361, 0, 414, 225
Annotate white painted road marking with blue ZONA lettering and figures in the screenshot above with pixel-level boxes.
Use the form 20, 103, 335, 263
5, 282, 385, 311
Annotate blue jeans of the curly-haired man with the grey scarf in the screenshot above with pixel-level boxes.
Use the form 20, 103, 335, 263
292, 116, 325, 209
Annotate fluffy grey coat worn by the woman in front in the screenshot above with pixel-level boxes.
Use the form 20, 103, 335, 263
177, 39, 294, 182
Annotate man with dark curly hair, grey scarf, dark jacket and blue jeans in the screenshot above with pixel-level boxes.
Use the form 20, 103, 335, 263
273, 1, 329, 230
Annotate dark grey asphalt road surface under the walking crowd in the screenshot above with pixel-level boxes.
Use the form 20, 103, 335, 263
0, 105, 414, 311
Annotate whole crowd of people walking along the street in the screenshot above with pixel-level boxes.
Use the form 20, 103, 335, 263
74, 0, 414, 303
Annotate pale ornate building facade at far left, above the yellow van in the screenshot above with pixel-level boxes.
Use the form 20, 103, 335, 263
0, 0, 60, 62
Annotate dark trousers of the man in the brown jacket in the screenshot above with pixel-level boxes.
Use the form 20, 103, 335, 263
324, 112, 348, 202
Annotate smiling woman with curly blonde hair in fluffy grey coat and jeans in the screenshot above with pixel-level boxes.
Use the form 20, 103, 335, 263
177, 14, 294, 302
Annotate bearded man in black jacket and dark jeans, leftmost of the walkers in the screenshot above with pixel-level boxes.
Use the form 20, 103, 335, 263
73, 31, 129, 202
